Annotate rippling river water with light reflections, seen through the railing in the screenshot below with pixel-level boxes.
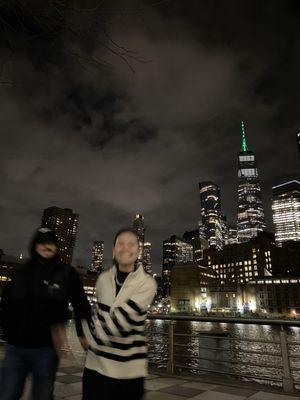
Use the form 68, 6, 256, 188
147, 320, 300, 385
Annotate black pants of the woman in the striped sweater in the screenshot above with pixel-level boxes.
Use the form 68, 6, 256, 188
82, 368, 144, 400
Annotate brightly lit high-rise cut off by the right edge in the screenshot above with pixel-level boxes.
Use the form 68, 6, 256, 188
272, 180, 300, 245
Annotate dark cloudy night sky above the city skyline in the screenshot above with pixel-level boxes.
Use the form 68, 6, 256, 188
0, 0, 300, 272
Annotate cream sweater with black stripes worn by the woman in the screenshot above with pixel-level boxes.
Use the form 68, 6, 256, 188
83, 267, 156, 379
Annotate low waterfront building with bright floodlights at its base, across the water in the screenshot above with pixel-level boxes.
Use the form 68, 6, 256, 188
171, 265, 300, 318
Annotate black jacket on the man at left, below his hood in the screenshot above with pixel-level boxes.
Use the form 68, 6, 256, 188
0, 257, 90, 347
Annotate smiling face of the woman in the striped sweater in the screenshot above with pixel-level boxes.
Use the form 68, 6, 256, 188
113, 232, 139, 265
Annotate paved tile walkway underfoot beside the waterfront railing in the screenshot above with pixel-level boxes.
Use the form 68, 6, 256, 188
0, 349, 300, 400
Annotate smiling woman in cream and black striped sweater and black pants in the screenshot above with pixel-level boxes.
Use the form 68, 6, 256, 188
82, 228, 156, 400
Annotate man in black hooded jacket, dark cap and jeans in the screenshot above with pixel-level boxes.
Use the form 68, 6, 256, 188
0, 228, 90, 400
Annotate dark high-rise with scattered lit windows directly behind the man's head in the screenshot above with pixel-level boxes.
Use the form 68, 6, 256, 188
42, 207, 79, 264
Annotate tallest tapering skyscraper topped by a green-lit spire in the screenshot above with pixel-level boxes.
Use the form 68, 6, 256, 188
237, 122, 266, 243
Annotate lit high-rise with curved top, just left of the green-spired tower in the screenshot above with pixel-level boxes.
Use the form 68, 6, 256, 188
199, 182, 223, 250
